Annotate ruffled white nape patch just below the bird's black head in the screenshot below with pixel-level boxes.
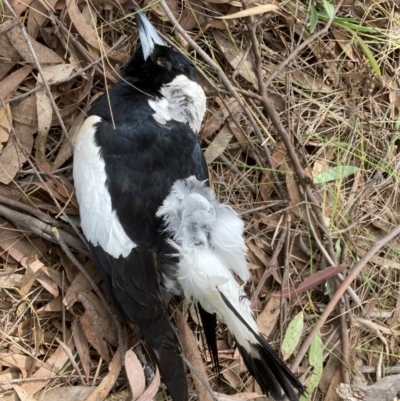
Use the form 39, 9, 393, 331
149, 75, 206, 134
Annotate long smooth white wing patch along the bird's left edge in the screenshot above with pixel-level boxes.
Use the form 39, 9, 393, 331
74, 116, 136, 258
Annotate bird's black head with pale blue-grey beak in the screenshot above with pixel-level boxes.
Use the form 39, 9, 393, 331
123, 12, 196, 91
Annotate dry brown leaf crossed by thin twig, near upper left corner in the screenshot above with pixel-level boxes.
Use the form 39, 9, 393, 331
6, 26, 64, 65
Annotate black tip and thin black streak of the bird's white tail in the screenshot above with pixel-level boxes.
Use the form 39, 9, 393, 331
219, 291, 305, 401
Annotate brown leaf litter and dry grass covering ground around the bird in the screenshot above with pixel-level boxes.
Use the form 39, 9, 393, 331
0, 0, 400, 401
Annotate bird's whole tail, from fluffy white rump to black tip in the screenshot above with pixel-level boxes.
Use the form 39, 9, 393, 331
158, 177, 304, 401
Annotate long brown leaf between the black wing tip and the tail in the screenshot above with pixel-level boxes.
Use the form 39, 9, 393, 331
175, 310, 212, 401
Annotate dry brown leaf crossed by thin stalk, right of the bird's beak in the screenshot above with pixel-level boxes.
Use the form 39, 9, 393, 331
214, 31, 258, 89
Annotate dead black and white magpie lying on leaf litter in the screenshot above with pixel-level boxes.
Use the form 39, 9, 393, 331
74, 8, 304, 401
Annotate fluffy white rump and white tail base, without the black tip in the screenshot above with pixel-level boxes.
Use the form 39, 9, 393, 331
157, 177, 258, 353
